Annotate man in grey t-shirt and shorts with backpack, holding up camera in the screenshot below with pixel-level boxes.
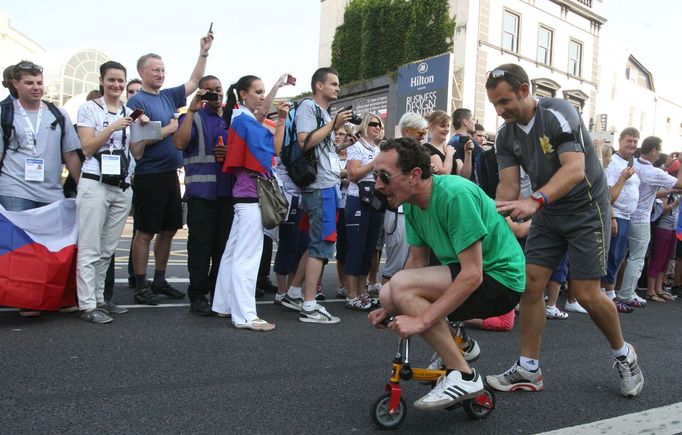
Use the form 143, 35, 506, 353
282, 68, 352, 324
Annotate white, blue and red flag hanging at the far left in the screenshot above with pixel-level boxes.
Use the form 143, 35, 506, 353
0, 199, 78, 311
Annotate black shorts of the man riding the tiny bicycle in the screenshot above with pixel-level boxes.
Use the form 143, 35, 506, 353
448, 263, 522, 322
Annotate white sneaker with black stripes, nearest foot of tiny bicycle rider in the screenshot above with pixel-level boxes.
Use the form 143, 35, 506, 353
414, 370, 484, 411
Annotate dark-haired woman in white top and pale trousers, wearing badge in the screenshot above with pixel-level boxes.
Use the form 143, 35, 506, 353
76, 61, 148, 323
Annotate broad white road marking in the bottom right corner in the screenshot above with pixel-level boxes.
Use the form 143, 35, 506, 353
540, 402, 682, 435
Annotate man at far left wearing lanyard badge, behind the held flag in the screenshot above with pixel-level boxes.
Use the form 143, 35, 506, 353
0, 60, 81, 317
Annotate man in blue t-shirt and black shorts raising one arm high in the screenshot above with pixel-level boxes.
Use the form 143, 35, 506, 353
128, 33, 213, 305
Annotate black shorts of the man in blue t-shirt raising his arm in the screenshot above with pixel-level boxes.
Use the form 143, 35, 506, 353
134, 171, 182, 234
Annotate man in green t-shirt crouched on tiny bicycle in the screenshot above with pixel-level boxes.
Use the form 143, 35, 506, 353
369, 138, 526, 410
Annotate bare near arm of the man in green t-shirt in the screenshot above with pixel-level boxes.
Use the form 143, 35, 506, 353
421, 240, 483, 330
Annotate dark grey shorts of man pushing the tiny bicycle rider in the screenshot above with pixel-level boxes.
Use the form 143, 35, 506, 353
525, 195, 611, 280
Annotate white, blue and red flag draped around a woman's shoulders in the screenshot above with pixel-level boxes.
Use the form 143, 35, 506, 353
223, 109, 275, 175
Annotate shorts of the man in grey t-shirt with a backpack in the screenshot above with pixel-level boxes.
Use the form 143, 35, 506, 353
301, 187, 339, 260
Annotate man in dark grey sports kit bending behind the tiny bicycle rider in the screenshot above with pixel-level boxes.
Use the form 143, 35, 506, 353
485, 64, 644, 396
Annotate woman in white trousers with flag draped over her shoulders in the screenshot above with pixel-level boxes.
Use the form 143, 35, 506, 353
213, 75, 289, 331
